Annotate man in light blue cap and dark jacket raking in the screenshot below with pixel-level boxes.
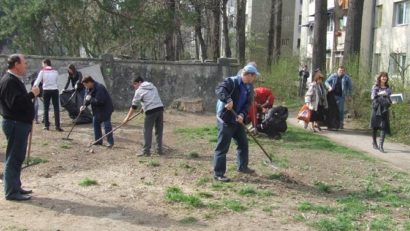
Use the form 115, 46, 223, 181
214, 65, 259, 182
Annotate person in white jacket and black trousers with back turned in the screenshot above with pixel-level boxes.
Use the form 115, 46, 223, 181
34, 59, 64, 132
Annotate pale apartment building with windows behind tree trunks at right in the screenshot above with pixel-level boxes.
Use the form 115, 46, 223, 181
300, 0, 410, 75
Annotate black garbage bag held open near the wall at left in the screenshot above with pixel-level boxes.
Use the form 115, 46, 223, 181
60, 89, 93, 124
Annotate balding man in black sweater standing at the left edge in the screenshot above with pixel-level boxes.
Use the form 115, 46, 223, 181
0, 54, 40, 201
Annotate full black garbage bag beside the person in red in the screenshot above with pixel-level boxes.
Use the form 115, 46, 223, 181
256, 106, 289, 138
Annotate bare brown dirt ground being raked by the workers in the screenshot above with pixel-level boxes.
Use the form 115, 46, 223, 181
0, 111, 408, 230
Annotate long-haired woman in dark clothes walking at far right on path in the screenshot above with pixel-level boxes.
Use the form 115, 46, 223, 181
370, 72, 392, 152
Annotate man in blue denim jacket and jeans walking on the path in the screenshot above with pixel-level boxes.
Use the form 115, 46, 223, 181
325, 66, 353, 129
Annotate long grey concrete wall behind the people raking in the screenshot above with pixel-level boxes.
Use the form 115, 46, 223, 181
0, 55, 240, 111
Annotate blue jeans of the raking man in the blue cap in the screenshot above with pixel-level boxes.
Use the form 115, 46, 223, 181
214, 121, 249, 176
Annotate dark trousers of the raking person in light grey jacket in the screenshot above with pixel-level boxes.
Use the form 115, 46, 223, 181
143, 110, 164, 154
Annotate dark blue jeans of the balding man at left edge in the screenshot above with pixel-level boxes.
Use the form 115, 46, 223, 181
2, 119, 32, 197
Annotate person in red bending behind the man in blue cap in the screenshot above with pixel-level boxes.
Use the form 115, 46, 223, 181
249, 87, 275, 128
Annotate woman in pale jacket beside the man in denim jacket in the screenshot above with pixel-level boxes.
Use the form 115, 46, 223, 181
305, 71, 328, 132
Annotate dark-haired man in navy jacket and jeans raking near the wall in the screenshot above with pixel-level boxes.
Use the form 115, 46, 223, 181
80, 76, 114, 148
